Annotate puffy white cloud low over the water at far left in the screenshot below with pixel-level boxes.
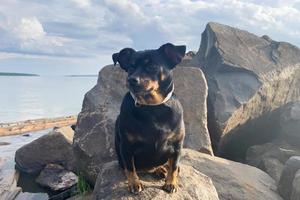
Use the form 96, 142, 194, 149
0, 17, 70, 55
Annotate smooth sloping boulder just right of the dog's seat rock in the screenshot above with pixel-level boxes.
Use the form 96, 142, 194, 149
181, 149, 282, 200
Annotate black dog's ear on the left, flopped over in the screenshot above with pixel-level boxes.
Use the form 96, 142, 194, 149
112, 48, 135, 71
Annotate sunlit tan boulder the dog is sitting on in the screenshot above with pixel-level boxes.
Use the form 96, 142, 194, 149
92, 161, 219, 200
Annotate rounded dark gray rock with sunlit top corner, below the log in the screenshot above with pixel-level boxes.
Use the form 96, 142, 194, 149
15, 127, 75, 173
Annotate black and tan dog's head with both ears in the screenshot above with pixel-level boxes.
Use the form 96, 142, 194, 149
112, 43, 186, 105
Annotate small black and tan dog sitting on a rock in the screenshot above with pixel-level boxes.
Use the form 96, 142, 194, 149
113, 43, 186, 193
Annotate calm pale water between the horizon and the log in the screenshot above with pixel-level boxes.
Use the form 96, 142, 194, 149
0, 76, 97, 123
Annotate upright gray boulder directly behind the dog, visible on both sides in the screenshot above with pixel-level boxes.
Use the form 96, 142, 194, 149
73, 66, 213, 183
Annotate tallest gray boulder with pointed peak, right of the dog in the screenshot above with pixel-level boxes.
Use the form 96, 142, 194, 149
193, 23, 300, 153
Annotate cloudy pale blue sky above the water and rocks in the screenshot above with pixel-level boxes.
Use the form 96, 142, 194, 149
0, 0, 300, 75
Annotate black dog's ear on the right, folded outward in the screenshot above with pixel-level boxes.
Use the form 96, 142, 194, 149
158, 43, 186, 69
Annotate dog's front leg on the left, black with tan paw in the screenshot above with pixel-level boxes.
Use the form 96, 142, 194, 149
121, 144, 144, 194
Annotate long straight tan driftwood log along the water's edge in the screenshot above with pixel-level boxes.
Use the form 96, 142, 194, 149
0, 115, 77, 137
